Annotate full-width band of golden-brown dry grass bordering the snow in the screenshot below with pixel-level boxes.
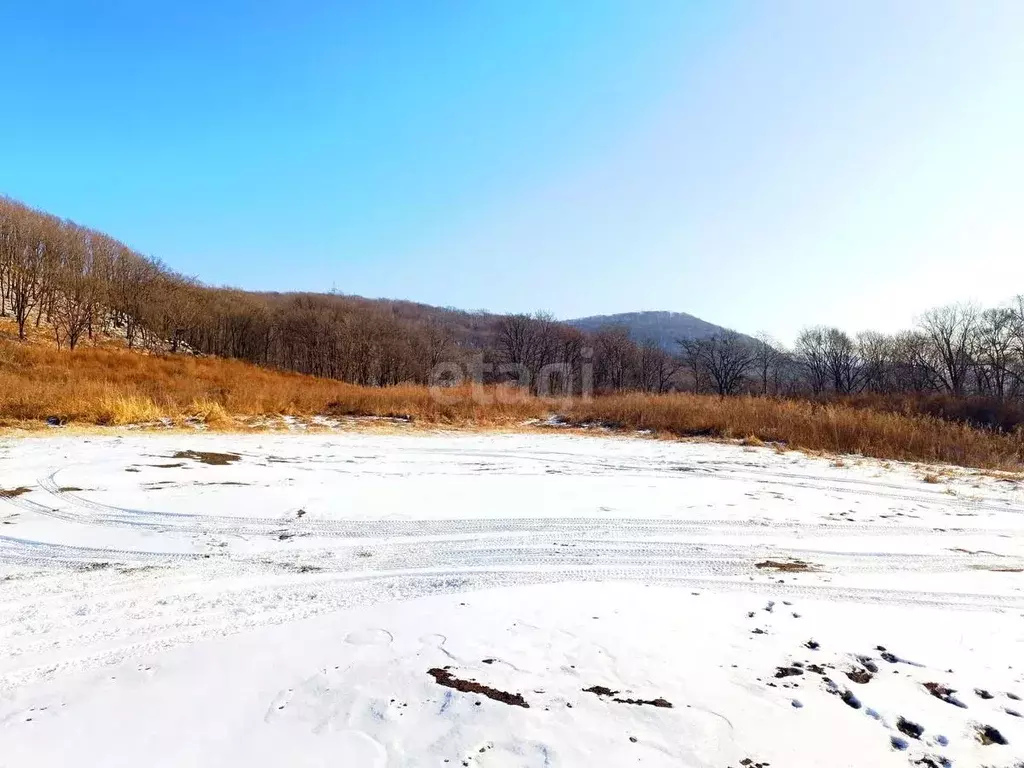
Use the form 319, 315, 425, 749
0, 341, 1024, 472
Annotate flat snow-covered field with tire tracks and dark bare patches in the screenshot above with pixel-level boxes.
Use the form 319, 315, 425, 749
0, 433, 1024, 768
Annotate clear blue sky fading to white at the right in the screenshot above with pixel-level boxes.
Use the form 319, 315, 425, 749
0, 0, 1024, 341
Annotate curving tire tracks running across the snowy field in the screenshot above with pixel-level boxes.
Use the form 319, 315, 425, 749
0, 438, 1024, 684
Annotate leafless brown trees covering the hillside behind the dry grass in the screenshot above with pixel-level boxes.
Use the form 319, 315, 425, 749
0, 199, 1024, 411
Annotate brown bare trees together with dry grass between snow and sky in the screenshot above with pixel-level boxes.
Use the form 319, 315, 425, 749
6, 192, 1024, 471
